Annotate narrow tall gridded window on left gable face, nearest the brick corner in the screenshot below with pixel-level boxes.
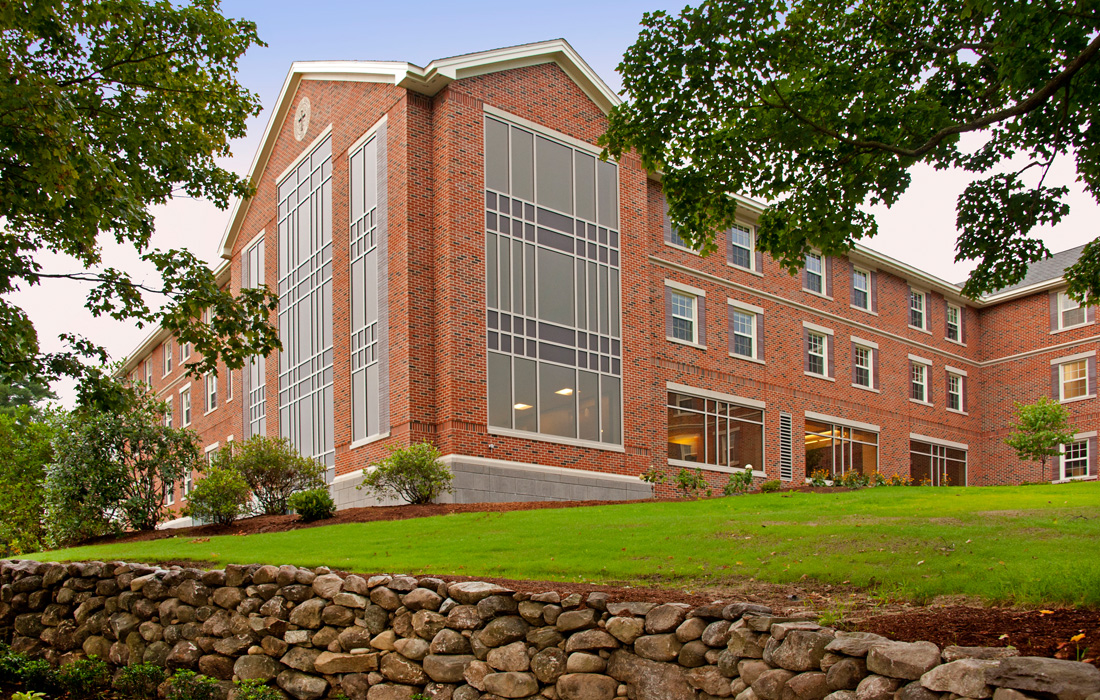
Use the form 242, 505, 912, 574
349, 125, 389, 440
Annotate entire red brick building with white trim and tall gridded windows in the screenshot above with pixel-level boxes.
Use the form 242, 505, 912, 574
116, 40, 1098, 519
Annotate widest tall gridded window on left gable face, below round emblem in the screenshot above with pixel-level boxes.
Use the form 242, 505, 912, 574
278, 139, 336, 467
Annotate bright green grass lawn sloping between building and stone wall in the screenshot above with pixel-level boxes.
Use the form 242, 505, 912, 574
35, 482, 1100, 606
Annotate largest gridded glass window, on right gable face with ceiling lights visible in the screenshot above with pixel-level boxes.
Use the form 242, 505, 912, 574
485, 118, 623, 445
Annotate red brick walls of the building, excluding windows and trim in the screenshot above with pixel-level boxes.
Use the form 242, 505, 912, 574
120, 40, 1098, 502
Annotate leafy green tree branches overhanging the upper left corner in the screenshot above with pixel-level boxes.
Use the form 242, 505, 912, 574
0, 0, 278, 401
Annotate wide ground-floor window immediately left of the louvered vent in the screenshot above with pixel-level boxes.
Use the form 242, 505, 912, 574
668, 392, 763, 471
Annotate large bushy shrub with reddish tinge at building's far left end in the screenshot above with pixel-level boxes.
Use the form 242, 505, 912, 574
46, 389, 199, 545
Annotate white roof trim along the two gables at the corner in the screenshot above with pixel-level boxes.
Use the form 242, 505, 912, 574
219, 39, 622, 260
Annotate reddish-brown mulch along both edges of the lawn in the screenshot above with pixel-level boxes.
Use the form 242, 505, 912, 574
77, 495, 1100, 665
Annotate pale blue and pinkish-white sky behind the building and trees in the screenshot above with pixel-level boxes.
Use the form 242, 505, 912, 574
13, 0, 1100, 403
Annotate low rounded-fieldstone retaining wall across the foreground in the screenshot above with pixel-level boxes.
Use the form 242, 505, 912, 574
0, 561, 1100, 700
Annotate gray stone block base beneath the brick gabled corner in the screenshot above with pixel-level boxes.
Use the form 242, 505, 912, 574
329, 455, 653, 510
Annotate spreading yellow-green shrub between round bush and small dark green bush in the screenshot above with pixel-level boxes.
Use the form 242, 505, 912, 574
215, 435, 325, 515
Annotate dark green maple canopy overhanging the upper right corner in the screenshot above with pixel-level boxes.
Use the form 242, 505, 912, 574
603, 0, 1100, 298
